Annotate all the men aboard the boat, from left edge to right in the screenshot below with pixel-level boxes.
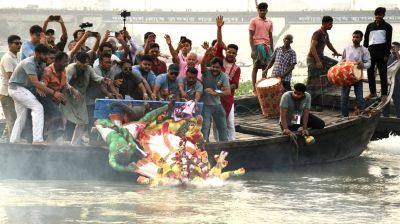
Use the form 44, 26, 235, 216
0, 3, 400, 145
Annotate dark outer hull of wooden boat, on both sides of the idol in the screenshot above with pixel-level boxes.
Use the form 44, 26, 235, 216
0, 113, 379, 181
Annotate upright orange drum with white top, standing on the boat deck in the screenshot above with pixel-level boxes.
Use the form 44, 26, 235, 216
256, 78, 283, 117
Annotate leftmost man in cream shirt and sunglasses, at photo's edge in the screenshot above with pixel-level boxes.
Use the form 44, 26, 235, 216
0, 35, 22, 137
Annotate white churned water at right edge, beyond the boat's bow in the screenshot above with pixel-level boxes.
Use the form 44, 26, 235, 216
367, 133, 400, 155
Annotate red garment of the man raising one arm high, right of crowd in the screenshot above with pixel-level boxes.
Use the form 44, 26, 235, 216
214, 44, 240, 116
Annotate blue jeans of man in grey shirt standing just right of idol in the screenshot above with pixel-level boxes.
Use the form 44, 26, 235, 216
201, 104, 228, 142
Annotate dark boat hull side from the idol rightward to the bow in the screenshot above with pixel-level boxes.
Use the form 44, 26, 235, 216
207, 113, 380, 170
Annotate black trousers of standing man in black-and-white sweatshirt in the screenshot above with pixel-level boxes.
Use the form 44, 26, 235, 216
367, 58, 388, 95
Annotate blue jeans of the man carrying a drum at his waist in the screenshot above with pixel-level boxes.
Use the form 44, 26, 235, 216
340, 80, 365, 117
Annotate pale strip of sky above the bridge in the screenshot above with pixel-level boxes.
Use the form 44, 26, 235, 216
0, 0, 400, 11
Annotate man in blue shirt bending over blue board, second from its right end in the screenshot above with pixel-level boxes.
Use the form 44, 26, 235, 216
152, 64, 179, 100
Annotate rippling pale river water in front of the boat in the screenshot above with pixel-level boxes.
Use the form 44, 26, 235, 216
0, 136, 400, 224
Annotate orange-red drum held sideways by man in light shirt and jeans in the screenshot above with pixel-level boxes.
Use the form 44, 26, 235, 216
327, 62, 363, 86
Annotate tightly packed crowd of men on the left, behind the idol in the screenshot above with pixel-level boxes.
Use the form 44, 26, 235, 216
0, 13, 240, 145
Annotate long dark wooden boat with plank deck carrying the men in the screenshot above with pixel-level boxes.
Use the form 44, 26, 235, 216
0, 60, 393, 180
